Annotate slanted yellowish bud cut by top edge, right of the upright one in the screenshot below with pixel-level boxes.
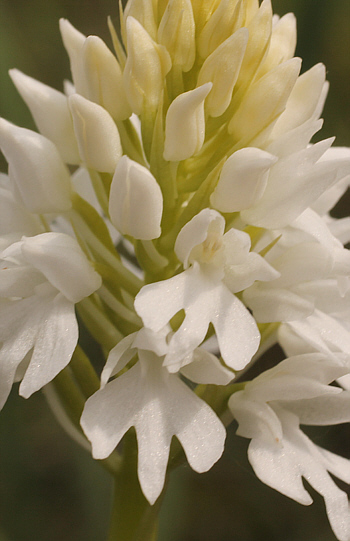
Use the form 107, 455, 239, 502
198, 0, 243, 58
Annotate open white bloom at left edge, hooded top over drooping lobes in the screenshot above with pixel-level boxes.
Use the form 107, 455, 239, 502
0, 233, 101, 407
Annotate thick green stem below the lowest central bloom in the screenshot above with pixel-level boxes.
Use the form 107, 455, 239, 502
108, 430, 162, 541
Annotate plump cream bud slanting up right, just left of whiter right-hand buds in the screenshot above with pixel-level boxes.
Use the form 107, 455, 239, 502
228, 58, 301, 141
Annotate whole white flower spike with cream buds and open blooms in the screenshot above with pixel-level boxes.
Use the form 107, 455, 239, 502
0, 0, 350, 541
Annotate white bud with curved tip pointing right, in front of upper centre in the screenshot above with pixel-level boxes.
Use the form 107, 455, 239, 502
163, 83, 213, 162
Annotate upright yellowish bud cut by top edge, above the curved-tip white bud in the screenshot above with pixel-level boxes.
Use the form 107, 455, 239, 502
158, 0, 196, 72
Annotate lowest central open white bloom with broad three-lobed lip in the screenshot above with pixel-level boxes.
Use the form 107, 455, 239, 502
81, 329, 226, 504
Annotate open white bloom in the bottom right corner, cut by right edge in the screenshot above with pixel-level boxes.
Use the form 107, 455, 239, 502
229, 354, 350, 541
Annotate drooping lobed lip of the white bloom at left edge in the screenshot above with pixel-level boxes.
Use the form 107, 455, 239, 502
0, 289, 78, 406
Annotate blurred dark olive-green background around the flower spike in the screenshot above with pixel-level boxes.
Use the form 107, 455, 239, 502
0, 0, 350, 541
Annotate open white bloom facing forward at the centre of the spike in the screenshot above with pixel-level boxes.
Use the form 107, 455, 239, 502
135, 209, 278, 371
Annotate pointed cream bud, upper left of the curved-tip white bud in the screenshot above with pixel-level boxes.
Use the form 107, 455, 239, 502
124, 16, 171, 115
